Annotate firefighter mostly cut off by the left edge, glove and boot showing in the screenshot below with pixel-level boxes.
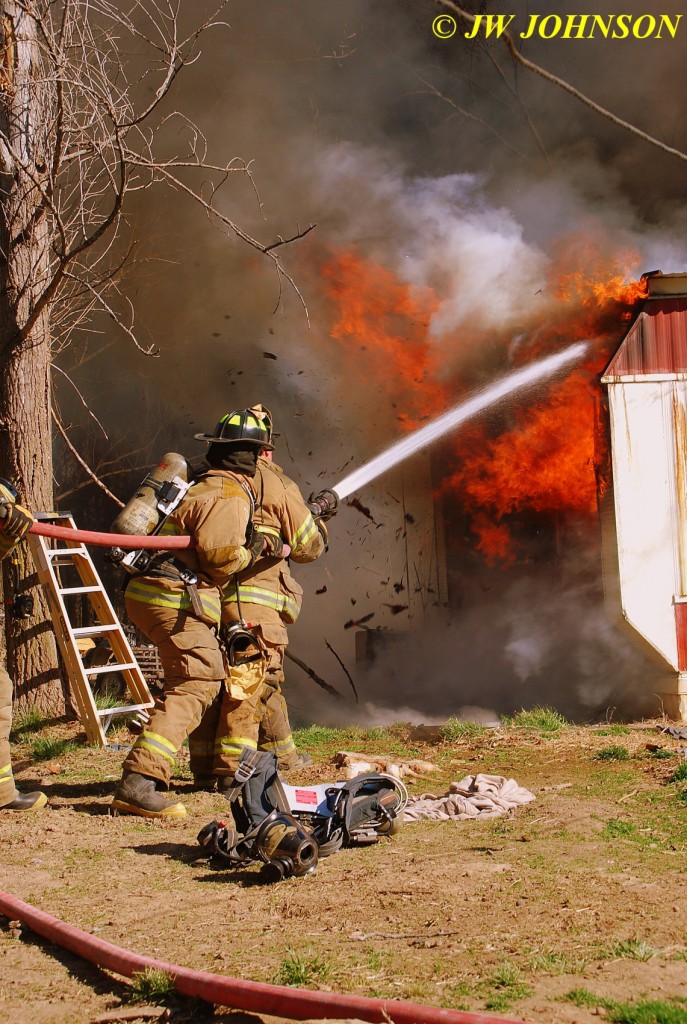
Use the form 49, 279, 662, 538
0, 478, 48, 811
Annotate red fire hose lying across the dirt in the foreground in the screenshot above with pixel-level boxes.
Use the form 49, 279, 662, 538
0, 892, 522, 1024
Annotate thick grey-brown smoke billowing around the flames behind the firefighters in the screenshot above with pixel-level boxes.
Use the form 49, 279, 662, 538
57, 6, 687, 721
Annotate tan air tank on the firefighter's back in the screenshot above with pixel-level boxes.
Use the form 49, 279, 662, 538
112, 452, 190, 537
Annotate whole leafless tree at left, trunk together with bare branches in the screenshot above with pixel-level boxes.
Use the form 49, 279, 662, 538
0, 0, 303, 712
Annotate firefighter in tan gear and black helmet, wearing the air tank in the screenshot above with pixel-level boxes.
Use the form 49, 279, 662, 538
112, 412, 270, 818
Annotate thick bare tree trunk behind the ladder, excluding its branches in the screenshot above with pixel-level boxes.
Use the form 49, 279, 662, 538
0, 3, 65, 714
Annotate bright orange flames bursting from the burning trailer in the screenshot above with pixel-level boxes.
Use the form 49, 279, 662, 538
321, 240, 646, 564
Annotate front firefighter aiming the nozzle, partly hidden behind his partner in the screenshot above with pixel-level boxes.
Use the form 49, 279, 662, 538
189, 406, 327, 788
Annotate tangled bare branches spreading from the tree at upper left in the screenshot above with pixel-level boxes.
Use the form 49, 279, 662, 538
0, 0, 314, 362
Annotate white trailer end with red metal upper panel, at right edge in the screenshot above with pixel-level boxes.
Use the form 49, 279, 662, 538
601, 271, 687, 720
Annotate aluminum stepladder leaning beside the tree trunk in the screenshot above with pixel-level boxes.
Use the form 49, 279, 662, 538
27, 513, 154, 746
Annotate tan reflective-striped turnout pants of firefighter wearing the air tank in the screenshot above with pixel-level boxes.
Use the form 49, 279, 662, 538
124, 597, 226, 785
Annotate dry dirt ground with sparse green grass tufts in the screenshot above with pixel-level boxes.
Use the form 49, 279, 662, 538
0, 723, 687, 1024
